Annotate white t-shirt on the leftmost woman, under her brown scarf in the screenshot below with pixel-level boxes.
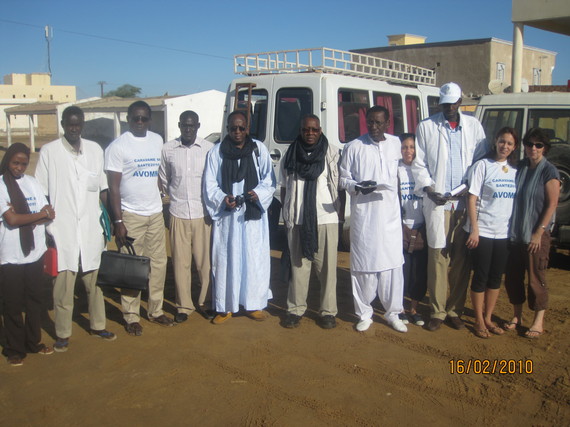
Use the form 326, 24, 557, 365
0, 171, 48, 265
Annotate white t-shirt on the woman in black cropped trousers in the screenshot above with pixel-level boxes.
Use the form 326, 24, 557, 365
464, 159, 517, 239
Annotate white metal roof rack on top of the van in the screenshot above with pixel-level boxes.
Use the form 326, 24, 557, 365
234, 47, 435, 86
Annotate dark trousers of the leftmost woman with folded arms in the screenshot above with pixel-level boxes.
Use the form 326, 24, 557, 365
1, 257, 43, 358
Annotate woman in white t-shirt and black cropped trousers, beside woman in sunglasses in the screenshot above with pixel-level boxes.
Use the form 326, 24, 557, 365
465, 127, 519, 338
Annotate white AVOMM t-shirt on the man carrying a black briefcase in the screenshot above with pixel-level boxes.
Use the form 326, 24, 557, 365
105, 131, 163, 216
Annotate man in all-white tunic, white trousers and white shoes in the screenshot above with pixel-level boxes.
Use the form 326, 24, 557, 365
340, 106, 407, 332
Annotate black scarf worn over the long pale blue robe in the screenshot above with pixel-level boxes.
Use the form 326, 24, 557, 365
220, 135, 261, 221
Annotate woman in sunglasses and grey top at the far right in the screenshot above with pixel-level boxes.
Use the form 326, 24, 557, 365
504, 128, 560, 338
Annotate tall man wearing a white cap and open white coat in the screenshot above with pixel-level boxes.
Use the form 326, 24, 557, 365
412, 83, 487, 331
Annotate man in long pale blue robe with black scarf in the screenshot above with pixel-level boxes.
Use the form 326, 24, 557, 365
204, 111, 275, 324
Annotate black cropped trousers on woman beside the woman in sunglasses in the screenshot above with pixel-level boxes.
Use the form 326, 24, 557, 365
471, 236, 509, 292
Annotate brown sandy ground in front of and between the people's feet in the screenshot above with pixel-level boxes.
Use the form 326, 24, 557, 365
0, 146, 570, 426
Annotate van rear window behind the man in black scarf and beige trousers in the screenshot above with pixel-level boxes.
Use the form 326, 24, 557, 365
274, 88, 313, 144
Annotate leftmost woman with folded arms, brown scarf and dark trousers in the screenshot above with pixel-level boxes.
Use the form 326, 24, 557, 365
0, 143, 55, 366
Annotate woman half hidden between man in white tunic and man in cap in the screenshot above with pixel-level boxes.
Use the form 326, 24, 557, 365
398, 133, 427, 326
